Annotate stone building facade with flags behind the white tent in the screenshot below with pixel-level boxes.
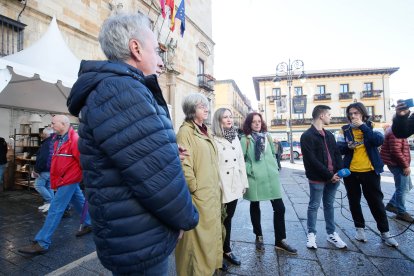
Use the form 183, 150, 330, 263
0, 0, 215, 129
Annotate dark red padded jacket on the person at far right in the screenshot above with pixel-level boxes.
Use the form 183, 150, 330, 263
381, 128, 411, 169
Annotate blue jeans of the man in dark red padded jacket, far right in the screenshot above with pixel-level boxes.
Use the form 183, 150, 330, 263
388, 166, 412, 213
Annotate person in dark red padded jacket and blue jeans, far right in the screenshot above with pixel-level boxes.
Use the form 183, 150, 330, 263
381, 128, 414, 222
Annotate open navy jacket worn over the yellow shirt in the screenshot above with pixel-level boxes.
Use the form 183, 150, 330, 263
337, 121, 384, 174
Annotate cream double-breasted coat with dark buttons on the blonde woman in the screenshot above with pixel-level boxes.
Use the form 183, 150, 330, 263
214, 136, 249, 203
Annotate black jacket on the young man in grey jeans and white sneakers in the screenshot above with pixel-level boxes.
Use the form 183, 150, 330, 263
300, 125, 343, 182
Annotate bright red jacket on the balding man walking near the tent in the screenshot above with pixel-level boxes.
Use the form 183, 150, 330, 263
50, 127, 82, 189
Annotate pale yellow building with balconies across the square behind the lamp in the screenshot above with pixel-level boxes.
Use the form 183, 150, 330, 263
253, 68, 399, 141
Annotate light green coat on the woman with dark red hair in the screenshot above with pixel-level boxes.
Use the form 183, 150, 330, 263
240, 135, 282, 201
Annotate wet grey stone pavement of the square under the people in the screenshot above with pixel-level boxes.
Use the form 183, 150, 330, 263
0, 161, 414, 275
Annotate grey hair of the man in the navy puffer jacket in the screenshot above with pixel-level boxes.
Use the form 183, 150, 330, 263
98, 13, 151, 61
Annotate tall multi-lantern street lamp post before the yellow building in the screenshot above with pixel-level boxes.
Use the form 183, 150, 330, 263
274, 59, 305, 163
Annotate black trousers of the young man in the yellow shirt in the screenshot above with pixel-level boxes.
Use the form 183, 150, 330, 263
344, 171, 389, 233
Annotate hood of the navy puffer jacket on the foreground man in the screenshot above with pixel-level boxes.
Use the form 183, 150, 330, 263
66, 60, 144, 116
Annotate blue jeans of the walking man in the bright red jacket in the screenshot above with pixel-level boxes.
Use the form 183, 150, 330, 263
34, 183, 91, 249
